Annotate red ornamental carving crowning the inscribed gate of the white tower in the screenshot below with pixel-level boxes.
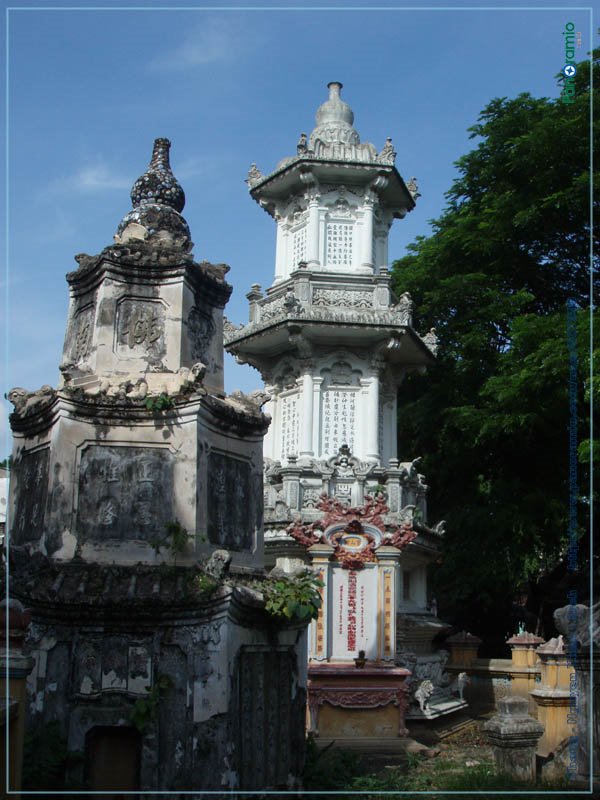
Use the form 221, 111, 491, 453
288, 494, 417, 570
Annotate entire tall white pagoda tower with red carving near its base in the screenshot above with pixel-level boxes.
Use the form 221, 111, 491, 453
225, 83, 464, 738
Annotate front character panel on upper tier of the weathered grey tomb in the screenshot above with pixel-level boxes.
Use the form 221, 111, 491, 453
116, 298, 165, 360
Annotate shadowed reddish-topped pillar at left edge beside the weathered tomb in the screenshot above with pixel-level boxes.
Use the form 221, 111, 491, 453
0, 599, 34, 800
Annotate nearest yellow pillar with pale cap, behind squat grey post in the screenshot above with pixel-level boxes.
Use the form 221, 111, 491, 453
531, 636, 573, 758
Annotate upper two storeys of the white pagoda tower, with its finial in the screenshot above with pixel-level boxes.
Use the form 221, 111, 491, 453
226, 82, 435, 506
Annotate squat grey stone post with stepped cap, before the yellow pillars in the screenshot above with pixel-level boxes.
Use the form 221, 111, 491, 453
483, 697, 544, 783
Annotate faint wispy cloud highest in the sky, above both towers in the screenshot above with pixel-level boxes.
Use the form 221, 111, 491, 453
147, 17, 243, 72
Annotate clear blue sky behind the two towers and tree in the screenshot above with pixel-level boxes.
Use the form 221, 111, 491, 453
0, 0, 590, 458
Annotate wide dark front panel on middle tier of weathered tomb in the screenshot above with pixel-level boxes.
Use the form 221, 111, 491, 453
77, 445, 173, 541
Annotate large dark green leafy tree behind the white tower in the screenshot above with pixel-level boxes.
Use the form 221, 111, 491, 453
393, 48, 600, 637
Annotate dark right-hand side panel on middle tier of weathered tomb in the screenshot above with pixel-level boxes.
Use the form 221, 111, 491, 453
207, 452, 252, 550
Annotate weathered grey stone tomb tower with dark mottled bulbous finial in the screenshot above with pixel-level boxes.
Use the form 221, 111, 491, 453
9, 139, 306, 790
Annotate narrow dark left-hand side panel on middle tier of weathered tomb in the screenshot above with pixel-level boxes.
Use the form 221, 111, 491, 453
11, 447, 50, 544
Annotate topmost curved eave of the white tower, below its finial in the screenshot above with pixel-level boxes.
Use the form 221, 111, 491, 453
250, 158, 415, 217
